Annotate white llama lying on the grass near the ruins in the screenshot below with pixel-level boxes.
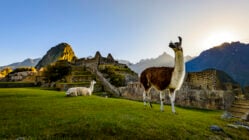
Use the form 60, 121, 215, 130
66, 80, 96, 96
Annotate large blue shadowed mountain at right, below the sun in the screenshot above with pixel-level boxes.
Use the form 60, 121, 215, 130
186, 42, 249, 86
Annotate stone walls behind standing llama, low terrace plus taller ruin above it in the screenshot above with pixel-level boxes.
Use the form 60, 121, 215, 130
119, 70, 242, 109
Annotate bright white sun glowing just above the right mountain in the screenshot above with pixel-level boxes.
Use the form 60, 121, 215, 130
203, 31, 237, 50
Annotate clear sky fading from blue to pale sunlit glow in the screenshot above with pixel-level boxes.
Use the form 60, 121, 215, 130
0, 0, 249, 66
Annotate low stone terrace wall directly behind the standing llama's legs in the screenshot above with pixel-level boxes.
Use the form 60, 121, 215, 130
119, 83, 234, 109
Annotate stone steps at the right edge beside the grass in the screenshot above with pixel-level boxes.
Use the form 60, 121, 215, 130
228, 100, 249, 121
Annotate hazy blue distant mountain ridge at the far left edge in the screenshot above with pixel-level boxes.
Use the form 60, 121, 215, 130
0, 58, 41, 70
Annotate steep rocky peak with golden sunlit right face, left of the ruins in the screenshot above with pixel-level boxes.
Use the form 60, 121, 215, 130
35, 43, 76, 69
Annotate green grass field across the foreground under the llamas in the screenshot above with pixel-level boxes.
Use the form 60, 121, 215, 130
0, 88, 249, 139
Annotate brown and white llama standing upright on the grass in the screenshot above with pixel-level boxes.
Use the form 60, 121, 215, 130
140, 36, 185, 113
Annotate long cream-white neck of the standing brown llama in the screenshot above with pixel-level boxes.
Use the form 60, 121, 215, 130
169, 51, 185, 90
